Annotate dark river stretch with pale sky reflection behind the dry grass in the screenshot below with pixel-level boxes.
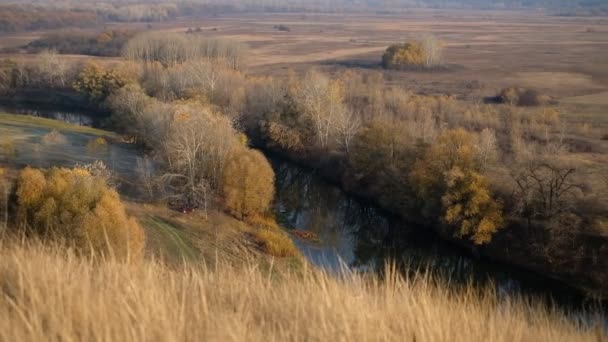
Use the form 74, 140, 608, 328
271, 158, 605, 320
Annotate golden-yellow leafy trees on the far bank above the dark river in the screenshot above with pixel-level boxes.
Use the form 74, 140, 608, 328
410, 129, 502, 244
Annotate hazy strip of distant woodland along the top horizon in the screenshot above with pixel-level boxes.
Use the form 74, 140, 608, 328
0, 0, 608, 32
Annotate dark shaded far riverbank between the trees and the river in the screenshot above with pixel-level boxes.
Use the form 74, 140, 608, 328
259, 144, 608, 300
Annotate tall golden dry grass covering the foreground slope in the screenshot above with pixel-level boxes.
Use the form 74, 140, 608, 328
0, 243, 606, 342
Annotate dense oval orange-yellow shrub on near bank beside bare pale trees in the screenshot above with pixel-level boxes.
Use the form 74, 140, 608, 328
222, 148, 274, 219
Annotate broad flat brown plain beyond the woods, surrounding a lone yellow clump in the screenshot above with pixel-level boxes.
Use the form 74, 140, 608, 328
0, 10, 608, 105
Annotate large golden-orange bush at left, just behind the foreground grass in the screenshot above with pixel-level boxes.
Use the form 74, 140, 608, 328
16, 167, 145, 259
